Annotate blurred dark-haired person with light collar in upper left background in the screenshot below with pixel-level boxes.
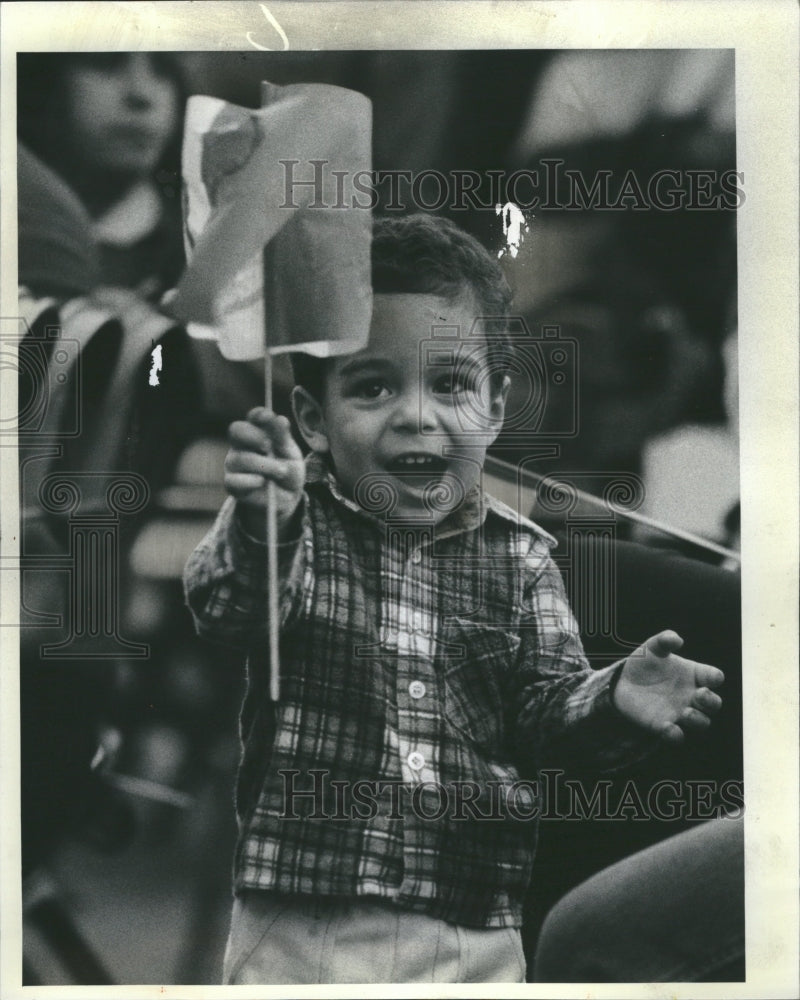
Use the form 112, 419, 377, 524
18, 52, 185, 301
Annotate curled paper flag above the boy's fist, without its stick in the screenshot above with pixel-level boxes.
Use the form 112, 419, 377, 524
170, 84, 372, 361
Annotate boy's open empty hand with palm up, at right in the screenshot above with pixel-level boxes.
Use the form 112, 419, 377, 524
614, 631, 725, 743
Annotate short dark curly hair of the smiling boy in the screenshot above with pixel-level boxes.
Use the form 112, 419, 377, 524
291, 213, 513, 400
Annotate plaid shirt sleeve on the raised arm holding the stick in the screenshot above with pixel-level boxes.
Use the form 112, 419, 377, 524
183, 496, 313, 649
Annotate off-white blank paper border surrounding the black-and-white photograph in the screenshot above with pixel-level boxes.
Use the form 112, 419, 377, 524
0, 0, 800, 1000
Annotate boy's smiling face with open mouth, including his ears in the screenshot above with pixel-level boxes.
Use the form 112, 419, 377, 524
293, 294, 508, 521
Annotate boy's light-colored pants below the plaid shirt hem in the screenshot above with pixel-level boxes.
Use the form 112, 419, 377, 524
223, 892, 525, 986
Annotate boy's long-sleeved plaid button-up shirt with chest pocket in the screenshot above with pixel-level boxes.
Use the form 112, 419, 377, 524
185, 456, 647, 927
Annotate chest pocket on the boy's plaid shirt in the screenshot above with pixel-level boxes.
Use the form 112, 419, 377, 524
442, 618, 521, 756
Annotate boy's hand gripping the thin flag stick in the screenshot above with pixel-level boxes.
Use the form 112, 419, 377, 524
224, 406, 305, 538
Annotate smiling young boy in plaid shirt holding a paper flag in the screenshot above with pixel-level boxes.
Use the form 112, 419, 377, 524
186, 216, 722, 984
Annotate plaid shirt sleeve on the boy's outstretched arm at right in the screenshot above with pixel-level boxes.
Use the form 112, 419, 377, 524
512, 539, 660, 771
